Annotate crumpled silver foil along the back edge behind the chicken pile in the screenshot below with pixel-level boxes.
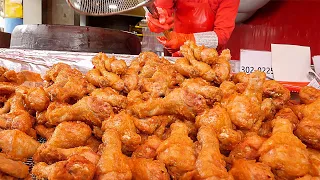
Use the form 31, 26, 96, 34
0, 48, 239, 75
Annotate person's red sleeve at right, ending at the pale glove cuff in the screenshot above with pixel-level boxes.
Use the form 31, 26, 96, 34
214, 0, 240, 47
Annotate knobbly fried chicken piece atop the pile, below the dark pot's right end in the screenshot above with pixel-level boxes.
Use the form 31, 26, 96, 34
86, 53, 127, 91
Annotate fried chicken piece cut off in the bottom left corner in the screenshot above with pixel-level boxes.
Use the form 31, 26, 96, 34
0, 153, 29, 179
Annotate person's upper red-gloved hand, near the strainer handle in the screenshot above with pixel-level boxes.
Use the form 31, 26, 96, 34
146, 7, 174, 33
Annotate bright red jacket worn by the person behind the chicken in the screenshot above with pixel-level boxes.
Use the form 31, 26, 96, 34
155, 0, 240, 47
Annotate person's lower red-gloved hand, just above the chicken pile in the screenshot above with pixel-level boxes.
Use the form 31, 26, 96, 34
157, 31, 195, 54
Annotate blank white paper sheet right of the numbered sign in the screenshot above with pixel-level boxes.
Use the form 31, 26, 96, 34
271, 44, 311, 82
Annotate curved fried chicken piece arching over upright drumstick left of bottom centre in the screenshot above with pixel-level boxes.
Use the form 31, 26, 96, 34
102, 111, 141, 151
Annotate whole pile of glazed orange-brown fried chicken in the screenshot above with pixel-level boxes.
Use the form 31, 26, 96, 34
0, 41, 320, 180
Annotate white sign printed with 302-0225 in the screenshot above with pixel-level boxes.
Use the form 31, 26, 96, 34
240, 49, 273, 79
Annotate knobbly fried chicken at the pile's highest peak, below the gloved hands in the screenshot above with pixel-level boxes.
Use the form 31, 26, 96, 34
175, 41, 231, 84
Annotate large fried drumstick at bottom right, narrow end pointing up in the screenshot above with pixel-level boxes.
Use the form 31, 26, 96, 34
259, 118, 310, 178
